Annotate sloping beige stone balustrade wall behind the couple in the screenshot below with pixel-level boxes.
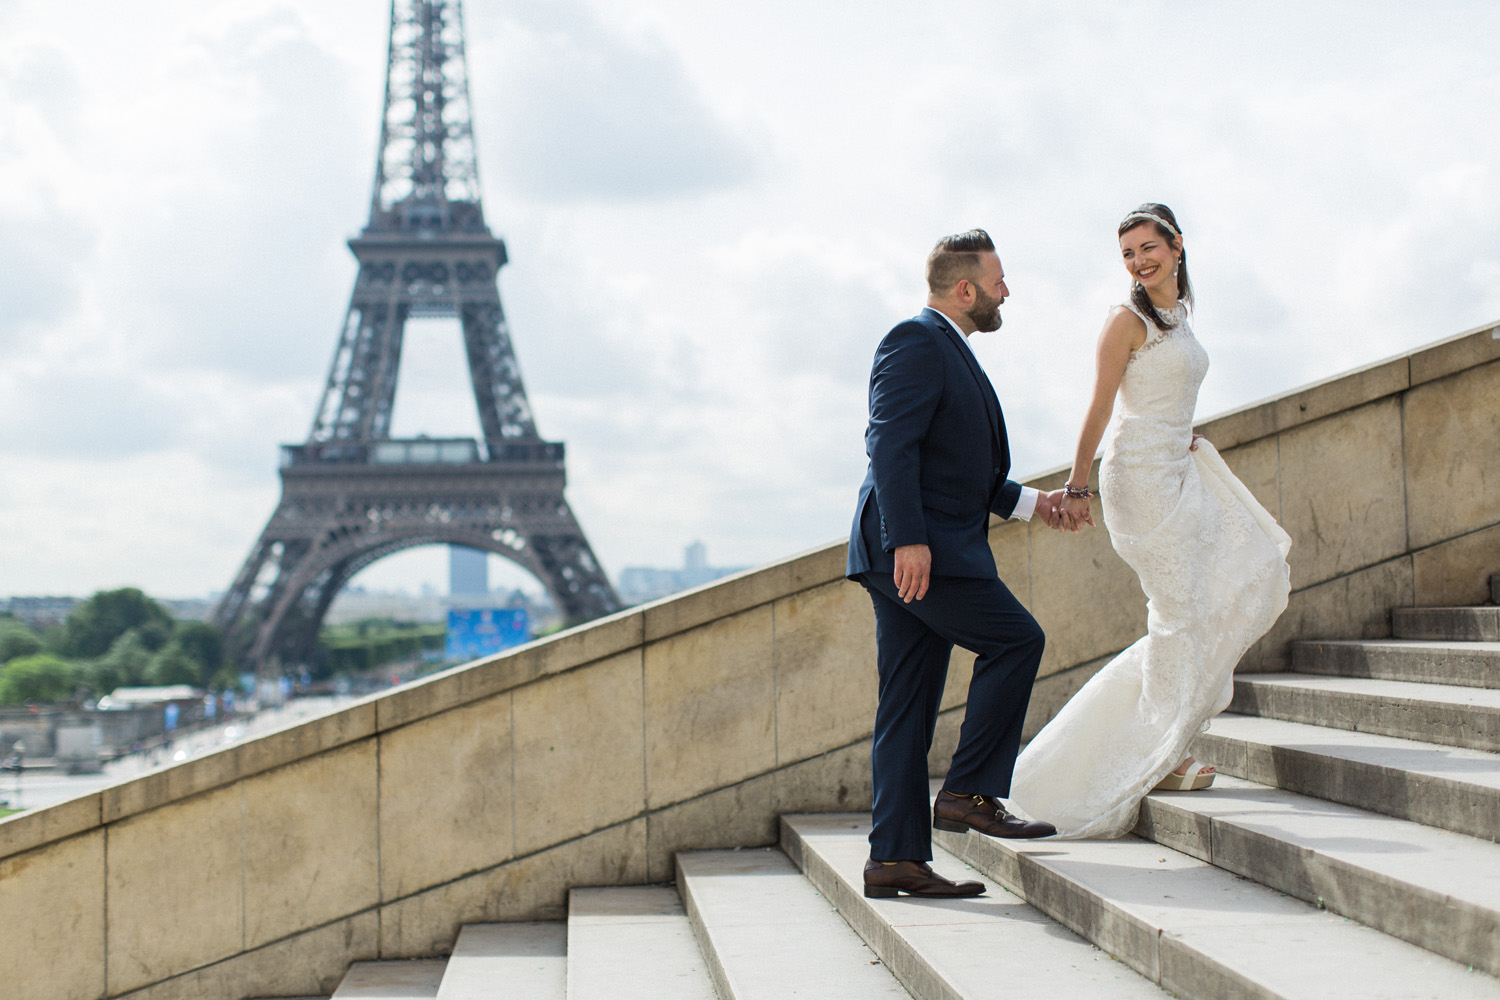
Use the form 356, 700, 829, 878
0, 320, 1500, 1000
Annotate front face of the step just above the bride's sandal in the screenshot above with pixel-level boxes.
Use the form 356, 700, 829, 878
1191, 723, 1500, 841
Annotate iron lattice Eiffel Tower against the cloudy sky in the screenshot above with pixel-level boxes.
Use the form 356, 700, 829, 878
215, 0, 620, 673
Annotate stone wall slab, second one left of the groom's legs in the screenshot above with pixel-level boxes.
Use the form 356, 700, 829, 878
645, 606, 776, 808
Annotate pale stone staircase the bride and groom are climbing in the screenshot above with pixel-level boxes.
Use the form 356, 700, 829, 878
273, 576, 1500, 1000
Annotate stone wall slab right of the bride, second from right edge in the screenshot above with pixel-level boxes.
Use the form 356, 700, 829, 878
1281, 399, 1407, 589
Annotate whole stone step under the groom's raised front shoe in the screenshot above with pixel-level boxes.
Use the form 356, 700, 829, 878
936, 815, 1500, 1000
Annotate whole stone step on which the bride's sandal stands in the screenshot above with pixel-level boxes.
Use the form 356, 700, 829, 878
1136, 775, 1500, 975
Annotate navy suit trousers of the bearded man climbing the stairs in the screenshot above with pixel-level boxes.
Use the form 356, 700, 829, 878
860, 571, 1046, 861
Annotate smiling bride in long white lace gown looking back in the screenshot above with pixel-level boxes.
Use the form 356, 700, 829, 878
1010, 204, 1292, 837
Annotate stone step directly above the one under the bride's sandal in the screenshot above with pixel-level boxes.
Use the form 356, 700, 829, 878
1193, 714, 1500, 840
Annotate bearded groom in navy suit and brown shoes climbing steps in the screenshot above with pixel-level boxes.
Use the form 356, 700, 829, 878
848, 229, 1062, 897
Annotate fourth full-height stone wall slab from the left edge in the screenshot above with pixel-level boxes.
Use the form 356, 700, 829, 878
380, 694, 515, 901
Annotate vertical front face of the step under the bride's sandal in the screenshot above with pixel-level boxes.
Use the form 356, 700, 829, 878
1133, 786, 1500, 976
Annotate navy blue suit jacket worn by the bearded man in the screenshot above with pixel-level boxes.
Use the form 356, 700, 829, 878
846, 309, 1022, 579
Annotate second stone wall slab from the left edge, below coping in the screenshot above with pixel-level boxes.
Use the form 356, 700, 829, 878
107, 787, 245, 994
